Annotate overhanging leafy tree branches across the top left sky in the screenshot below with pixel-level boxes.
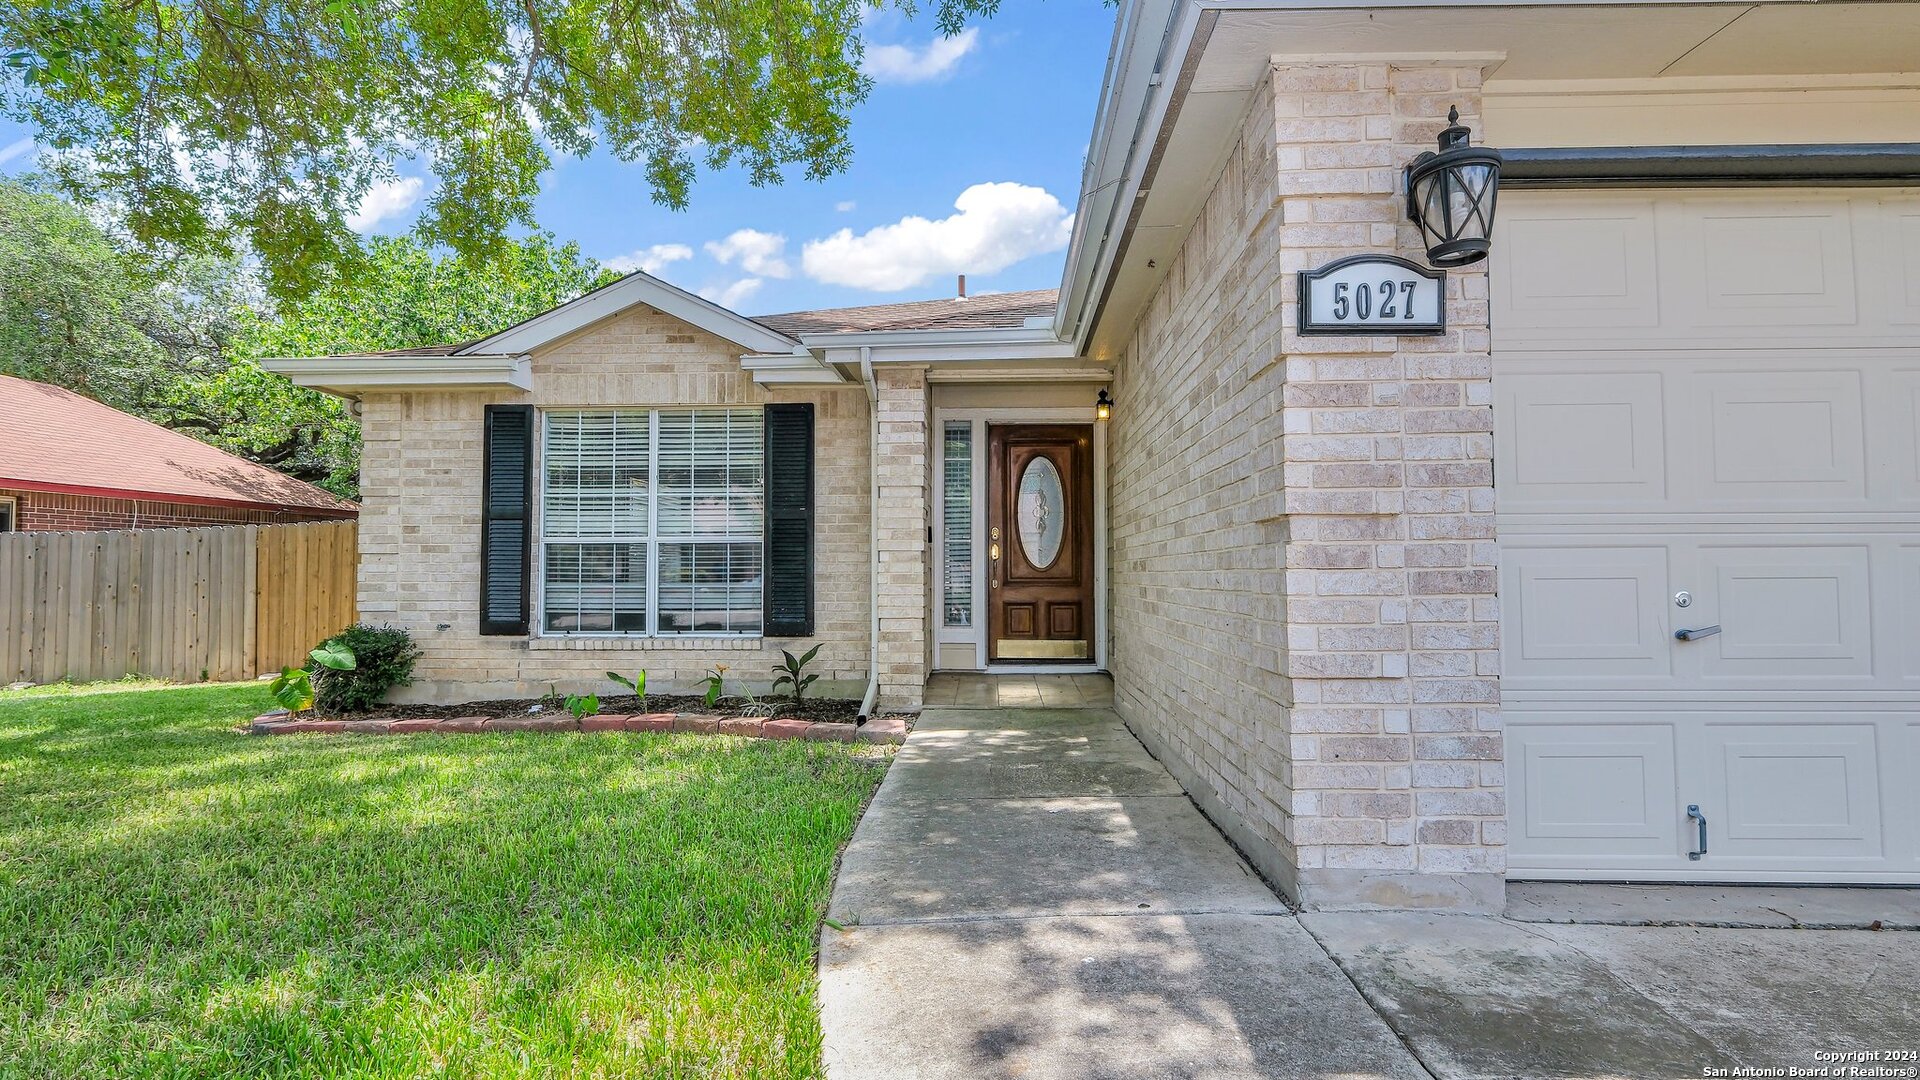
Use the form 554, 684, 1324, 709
0, 0, 998, 296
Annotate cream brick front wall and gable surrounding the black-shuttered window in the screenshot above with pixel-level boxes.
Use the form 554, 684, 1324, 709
359, 307, 870, 701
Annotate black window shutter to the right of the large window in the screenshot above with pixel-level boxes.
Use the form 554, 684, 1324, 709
766, 402, 814, 638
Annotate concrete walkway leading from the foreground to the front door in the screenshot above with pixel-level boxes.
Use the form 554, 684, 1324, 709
820, 707, 1427, 1080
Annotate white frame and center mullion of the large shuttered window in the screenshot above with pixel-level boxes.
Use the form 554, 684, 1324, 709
528, 405, 766, 638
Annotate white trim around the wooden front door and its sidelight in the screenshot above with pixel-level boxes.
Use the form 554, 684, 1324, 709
927, 405, 1110, 675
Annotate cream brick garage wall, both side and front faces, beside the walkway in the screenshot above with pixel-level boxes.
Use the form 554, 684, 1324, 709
1110, 61, 1505, 909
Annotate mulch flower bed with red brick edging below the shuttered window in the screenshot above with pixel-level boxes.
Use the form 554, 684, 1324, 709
248, 694, 908, 746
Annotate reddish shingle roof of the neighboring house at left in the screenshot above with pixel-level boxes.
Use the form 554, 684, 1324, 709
0, 375, 359, 515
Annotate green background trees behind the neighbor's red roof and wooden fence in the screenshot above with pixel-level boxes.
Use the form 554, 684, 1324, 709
0, 183, 616, 498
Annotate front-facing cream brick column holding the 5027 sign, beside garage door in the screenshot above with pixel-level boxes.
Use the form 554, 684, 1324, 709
1273, 61, 1505, 909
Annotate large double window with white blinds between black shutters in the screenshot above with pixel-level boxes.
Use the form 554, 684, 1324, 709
540, 409, 766, 634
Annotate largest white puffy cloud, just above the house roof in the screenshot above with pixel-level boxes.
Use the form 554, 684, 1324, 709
801, 183, 1073, 292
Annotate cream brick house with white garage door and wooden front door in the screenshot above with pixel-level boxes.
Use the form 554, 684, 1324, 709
273, 0, 1920, 909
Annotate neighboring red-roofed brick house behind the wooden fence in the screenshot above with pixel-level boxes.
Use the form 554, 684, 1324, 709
0, 375, 359, 532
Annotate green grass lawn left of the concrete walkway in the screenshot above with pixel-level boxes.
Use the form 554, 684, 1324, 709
0, 684, 881, 1078
